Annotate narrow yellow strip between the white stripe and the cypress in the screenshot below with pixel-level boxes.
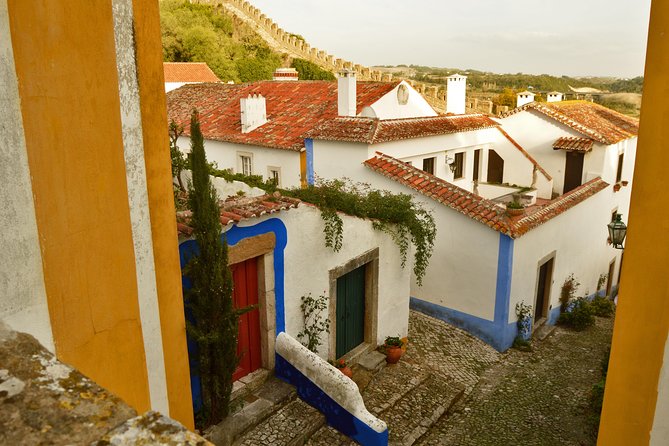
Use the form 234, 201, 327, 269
133, 0, 194, 429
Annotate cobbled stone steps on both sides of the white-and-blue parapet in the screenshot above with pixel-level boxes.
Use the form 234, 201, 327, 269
207, 352, 464, 446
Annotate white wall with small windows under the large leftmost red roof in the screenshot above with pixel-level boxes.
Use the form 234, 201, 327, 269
177, 136, 300, 188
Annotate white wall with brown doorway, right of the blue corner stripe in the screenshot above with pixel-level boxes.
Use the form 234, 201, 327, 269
509, 187, 627, 322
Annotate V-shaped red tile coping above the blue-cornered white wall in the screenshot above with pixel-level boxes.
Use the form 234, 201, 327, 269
365, 152, 608, 238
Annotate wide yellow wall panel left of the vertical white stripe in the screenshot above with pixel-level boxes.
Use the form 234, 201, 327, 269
8, 0, 149, 411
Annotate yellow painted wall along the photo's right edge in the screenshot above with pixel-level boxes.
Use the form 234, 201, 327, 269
598, 0, 669, 446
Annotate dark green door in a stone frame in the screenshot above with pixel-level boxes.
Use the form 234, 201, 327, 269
336, 265, 365, 358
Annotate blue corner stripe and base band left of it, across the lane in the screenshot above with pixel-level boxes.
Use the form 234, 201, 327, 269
410, 234, 518, 352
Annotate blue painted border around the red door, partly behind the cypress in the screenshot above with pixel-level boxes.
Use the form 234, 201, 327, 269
179, 218, 288, 413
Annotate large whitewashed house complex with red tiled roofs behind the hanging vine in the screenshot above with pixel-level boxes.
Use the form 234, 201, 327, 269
168, 67, 636, 350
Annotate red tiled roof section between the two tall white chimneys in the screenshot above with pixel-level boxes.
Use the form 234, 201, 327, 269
305, 114, 499, 144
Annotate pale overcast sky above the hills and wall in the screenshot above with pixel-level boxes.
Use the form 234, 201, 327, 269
250, 0, 650, 77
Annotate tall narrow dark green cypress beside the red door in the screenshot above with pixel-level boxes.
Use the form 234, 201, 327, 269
185, 110, 240, 425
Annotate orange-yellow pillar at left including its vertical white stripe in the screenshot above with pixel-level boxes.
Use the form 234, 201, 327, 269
6, 0, 193, 428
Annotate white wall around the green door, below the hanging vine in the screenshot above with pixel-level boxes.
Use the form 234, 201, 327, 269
235, 203, 411, 356
